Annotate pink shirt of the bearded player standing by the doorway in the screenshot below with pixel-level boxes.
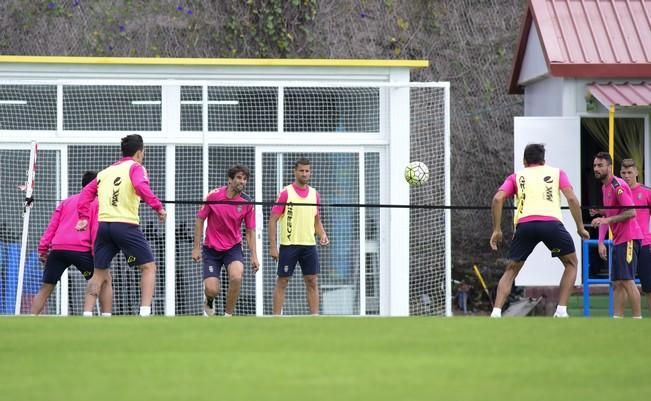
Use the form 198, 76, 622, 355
599, 176, 644, 245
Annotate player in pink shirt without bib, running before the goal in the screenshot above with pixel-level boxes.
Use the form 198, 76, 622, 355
192, 165, 260, 317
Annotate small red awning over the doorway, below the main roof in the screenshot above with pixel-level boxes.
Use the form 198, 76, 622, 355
588, 82, 651, 107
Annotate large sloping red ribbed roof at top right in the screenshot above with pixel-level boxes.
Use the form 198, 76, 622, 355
509, 0, 651, 93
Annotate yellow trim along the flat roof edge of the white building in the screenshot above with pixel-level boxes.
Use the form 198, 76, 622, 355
0, 56, 429, 68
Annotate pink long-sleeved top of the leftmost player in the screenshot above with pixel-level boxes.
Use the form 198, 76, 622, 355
38, 194, 97, 255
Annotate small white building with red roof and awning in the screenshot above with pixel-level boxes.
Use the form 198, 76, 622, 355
508, 0, 651, 286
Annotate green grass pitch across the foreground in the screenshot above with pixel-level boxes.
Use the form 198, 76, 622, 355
0, 317, 651, 401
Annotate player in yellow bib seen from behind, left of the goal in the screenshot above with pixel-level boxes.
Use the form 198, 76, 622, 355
76, 134, 167, 316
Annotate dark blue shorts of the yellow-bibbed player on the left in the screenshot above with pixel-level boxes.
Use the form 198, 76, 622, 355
95, 221, 154, 269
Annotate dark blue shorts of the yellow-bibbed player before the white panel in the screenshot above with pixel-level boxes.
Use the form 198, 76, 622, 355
509, 220, 576, 262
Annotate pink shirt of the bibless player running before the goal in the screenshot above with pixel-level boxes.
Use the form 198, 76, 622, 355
197, 186, 255, 251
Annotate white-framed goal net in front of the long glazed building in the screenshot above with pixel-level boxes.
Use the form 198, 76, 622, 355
0, 83, 451, 315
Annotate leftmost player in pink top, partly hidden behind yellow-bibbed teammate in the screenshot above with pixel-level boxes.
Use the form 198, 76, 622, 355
32, 171, 113, 316
